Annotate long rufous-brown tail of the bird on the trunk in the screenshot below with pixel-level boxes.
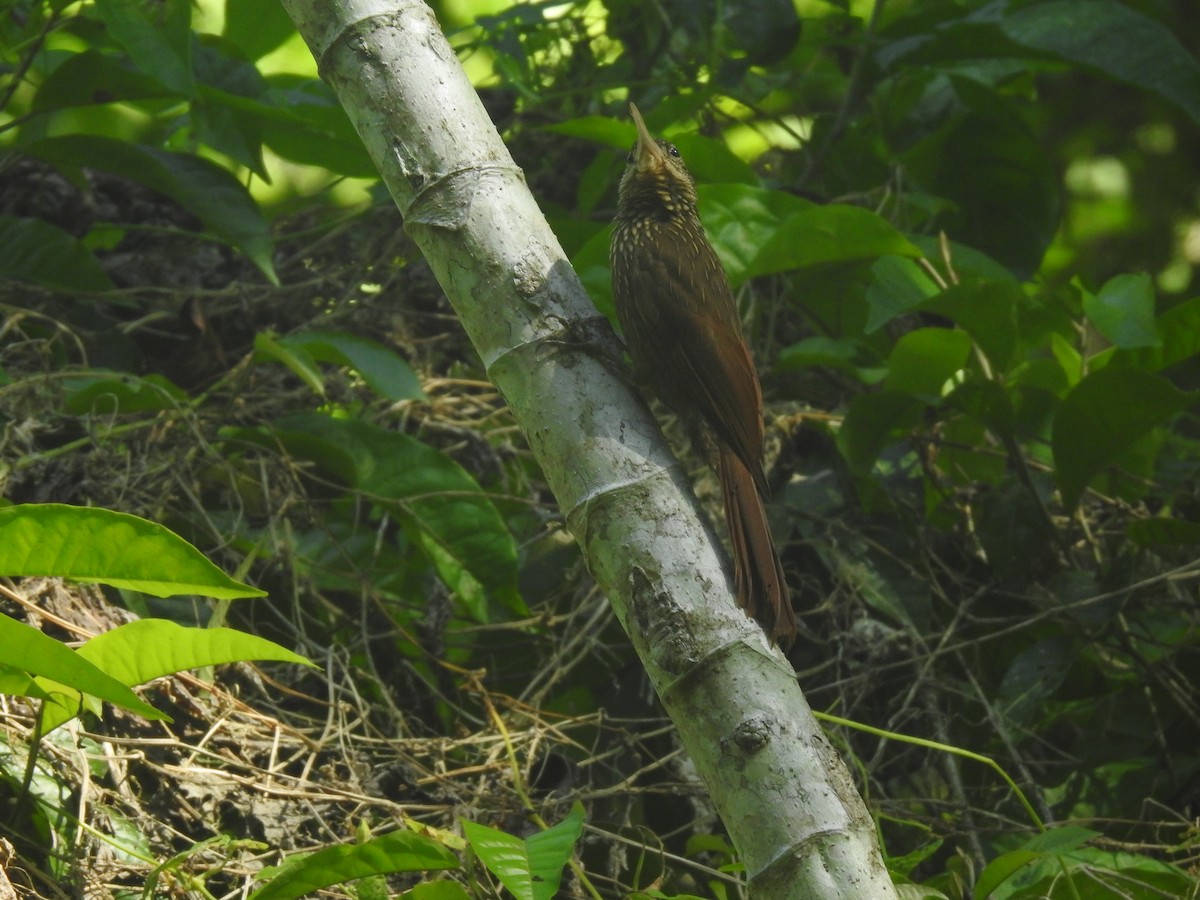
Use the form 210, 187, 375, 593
720, 444, 796, 649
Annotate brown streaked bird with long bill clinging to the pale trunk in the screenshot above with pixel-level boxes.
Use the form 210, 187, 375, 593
610, 103, 796, 649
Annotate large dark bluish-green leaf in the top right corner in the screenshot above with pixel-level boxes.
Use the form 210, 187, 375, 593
1000, 0, 1200, 124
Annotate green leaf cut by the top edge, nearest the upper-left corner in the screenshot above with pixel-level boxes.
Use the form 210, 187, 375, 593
96, 0, 194, 97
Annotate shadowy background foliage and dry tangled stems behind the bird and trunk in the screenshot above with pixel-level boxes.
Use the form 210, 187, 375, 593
0, 0, 1200, 898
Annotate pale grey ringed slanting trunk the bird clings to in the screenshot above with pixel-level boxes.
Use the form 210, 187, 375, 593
284, 0, 895, 900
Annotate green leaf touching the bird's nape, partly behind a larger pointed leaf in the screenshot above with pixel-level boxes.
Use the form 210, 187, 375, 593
697, 185, 812, 287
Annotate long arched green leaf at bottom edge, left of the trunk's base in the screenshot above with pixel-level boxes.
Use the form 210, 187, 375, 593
250, 830, 458, 900
